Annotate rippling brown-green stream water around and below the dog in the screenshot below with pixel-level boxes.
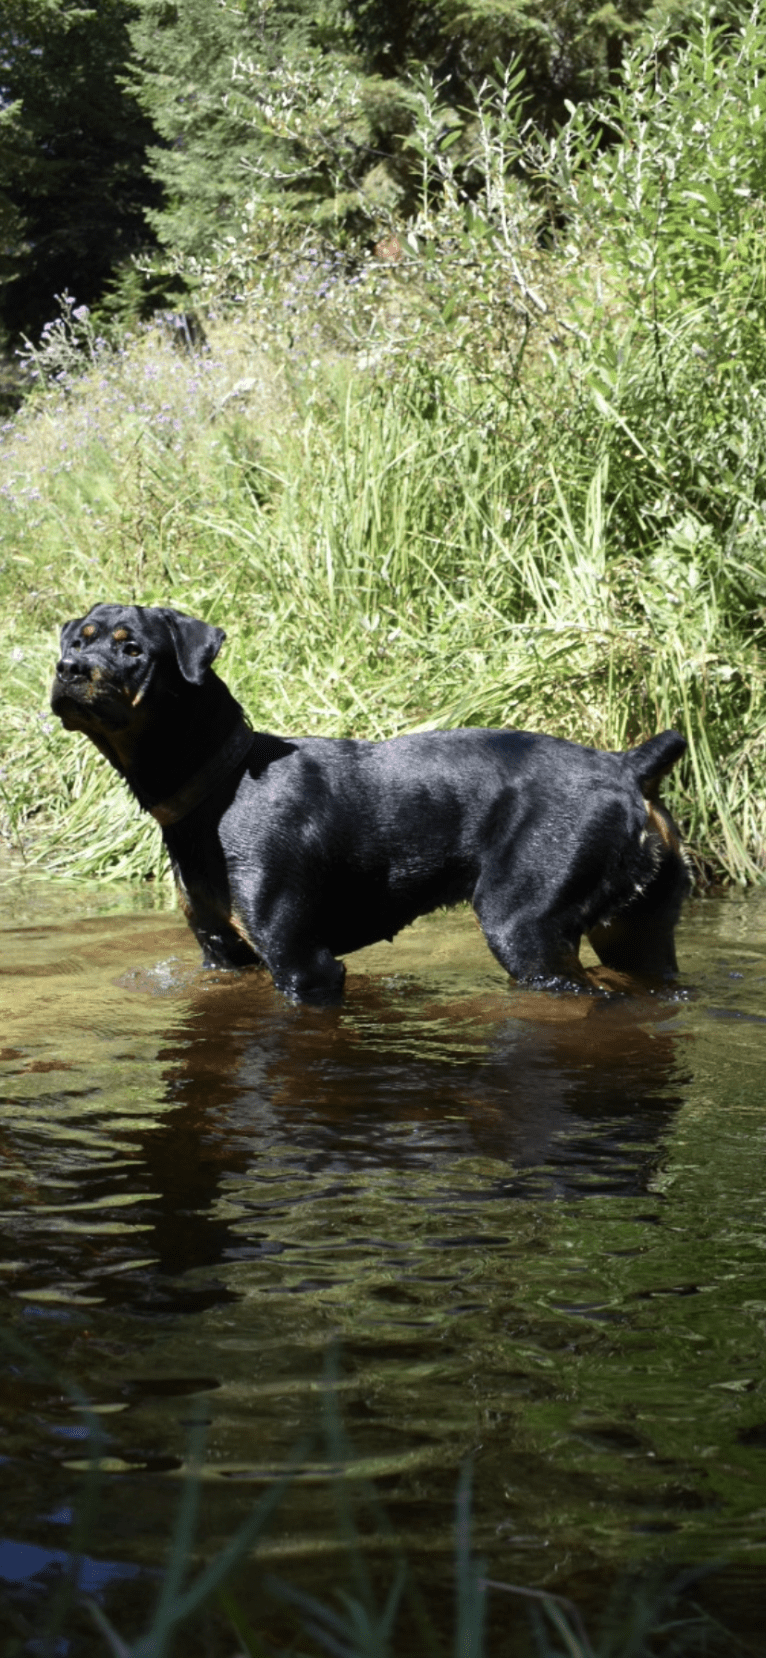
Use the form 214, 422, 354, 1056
0, 882, 766, 1655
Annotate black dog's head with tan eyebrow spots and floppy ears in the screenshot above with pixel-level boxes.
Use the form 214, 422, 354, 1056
51, 605, 225, 766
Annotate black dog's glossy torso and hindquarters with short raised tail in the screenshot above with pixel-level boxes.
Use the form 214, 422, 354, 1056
221, 728, 688, 980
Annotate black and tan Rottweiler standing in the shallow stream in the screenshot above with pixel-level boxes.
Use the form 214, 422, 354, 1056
51, 605, 690, 1000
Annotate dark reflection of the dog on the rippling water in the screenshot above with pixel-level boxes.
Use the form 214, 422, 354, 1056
119, 973, 686, 1313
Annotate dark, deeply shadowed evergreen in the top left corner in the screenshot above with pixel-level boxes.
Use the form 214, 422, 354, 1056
0, 0, 158, 332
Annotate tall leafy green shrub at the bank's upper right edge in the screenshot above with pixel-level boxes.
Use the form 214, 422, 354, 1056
555, 12, 766, 543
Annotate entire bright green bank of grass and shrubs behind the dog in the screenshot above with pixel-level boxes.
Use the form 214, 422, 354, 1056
0, 6, 766, 880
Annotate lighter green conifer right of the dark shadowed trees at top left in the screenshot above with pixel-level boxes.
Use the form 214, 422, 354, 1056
131, 0, 366, 259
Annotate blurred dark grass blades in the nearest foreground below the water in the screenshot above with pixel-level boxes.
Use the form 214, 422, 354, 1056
0, 1328, 739, 1658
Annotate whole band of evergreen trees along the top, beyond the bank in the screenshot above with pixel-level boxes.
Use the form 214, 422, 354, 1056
0, 0, 759, 344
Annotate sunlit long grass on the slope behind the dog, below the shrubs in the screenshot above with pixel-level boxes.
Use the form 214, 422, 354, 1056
0, 308, 766, 879
